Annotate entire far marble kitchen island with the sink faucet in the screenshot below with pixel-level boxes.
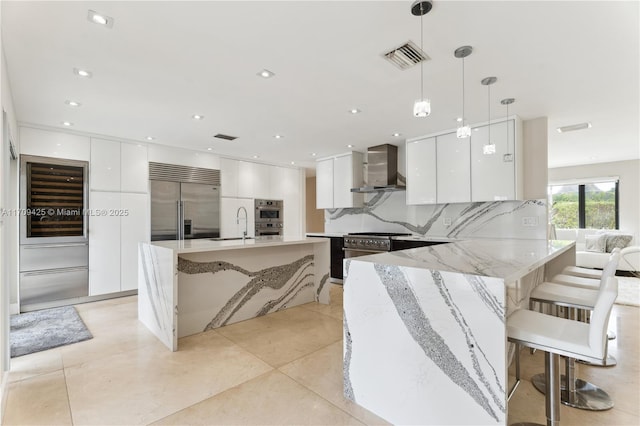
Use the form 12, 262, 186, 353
138, 237, 329, 351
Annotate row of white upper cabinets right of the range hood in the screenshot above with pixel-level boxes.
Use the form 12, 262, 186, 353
406, 117, 523, 204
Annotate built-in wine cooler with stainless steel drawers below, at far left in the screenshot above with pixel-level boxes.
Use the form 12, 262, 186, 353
19, 155, 89, 312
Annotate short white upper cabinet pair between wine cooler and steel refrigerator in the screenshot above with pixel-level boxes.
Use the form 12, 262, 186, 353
89, 138, 149, 193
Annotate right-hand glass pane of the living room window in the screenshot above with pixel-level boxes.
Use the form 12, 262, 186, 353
584, 182, 616, 229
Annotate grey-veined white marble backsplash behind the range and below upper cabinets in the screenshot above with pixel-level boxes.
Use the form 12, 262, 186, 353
324, 191, 547, 239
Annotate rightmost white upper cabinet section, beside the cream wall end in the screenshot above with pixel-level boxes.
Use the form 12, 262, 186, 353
471, 120, 521, 201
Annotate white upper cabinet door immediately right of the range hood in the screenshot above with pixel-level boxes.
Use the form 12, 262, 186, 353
406, 137, 437, 204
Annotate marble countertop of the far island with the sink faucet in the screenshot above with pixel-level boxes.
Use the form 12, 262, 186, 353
151, 236, 329, 254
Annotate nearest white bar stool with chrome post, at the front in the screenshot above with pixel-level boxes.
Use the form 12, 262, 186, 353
507, 277, 618, 426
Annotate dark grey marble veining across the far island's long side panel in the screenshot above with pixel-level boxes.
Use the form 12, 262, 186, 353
178, 255, 314, 331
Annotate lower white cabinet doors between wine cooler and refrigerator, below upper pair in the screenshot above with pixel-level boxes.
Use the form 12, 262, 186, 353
88, 191, 149, 296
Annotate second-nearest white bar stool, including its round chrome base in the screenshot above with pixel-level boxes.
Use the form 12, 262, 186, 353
529, 253, 620, 411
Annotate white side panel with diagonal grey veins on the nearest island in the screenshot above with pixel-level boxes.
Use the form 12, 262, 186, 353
344, 260, 507, 425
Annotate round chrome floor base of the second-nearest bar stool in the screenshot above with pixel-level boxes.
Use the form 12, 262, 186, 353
531, 373, 613, 411
